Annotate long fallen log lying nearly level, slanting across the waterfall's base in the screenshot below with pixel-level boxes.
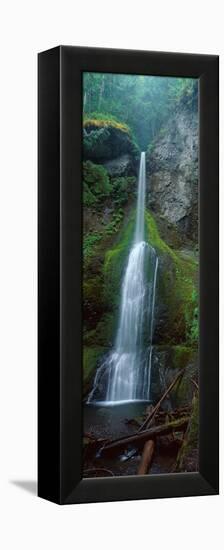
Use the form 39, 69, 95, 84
100, 416, 190, 456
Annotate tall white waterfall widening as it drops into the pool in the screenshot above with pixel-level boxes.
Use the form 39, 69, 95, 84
88, 153, 158, 404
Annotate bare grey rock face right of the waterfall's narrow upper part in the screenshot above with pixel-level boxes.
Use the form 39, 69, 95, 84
147, 104, 198, 242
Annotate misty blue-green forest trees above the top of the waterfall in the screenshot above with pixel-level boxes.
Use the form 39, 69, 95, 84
83, 72, 198, 150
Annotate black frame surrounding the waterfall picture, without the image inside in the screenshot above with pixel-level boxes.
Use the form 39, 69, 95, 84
38, 46, 219, 504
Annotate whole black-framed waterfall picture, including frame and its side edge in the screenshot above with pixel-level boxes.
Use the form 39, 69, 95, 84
38, 46, 219, 504
